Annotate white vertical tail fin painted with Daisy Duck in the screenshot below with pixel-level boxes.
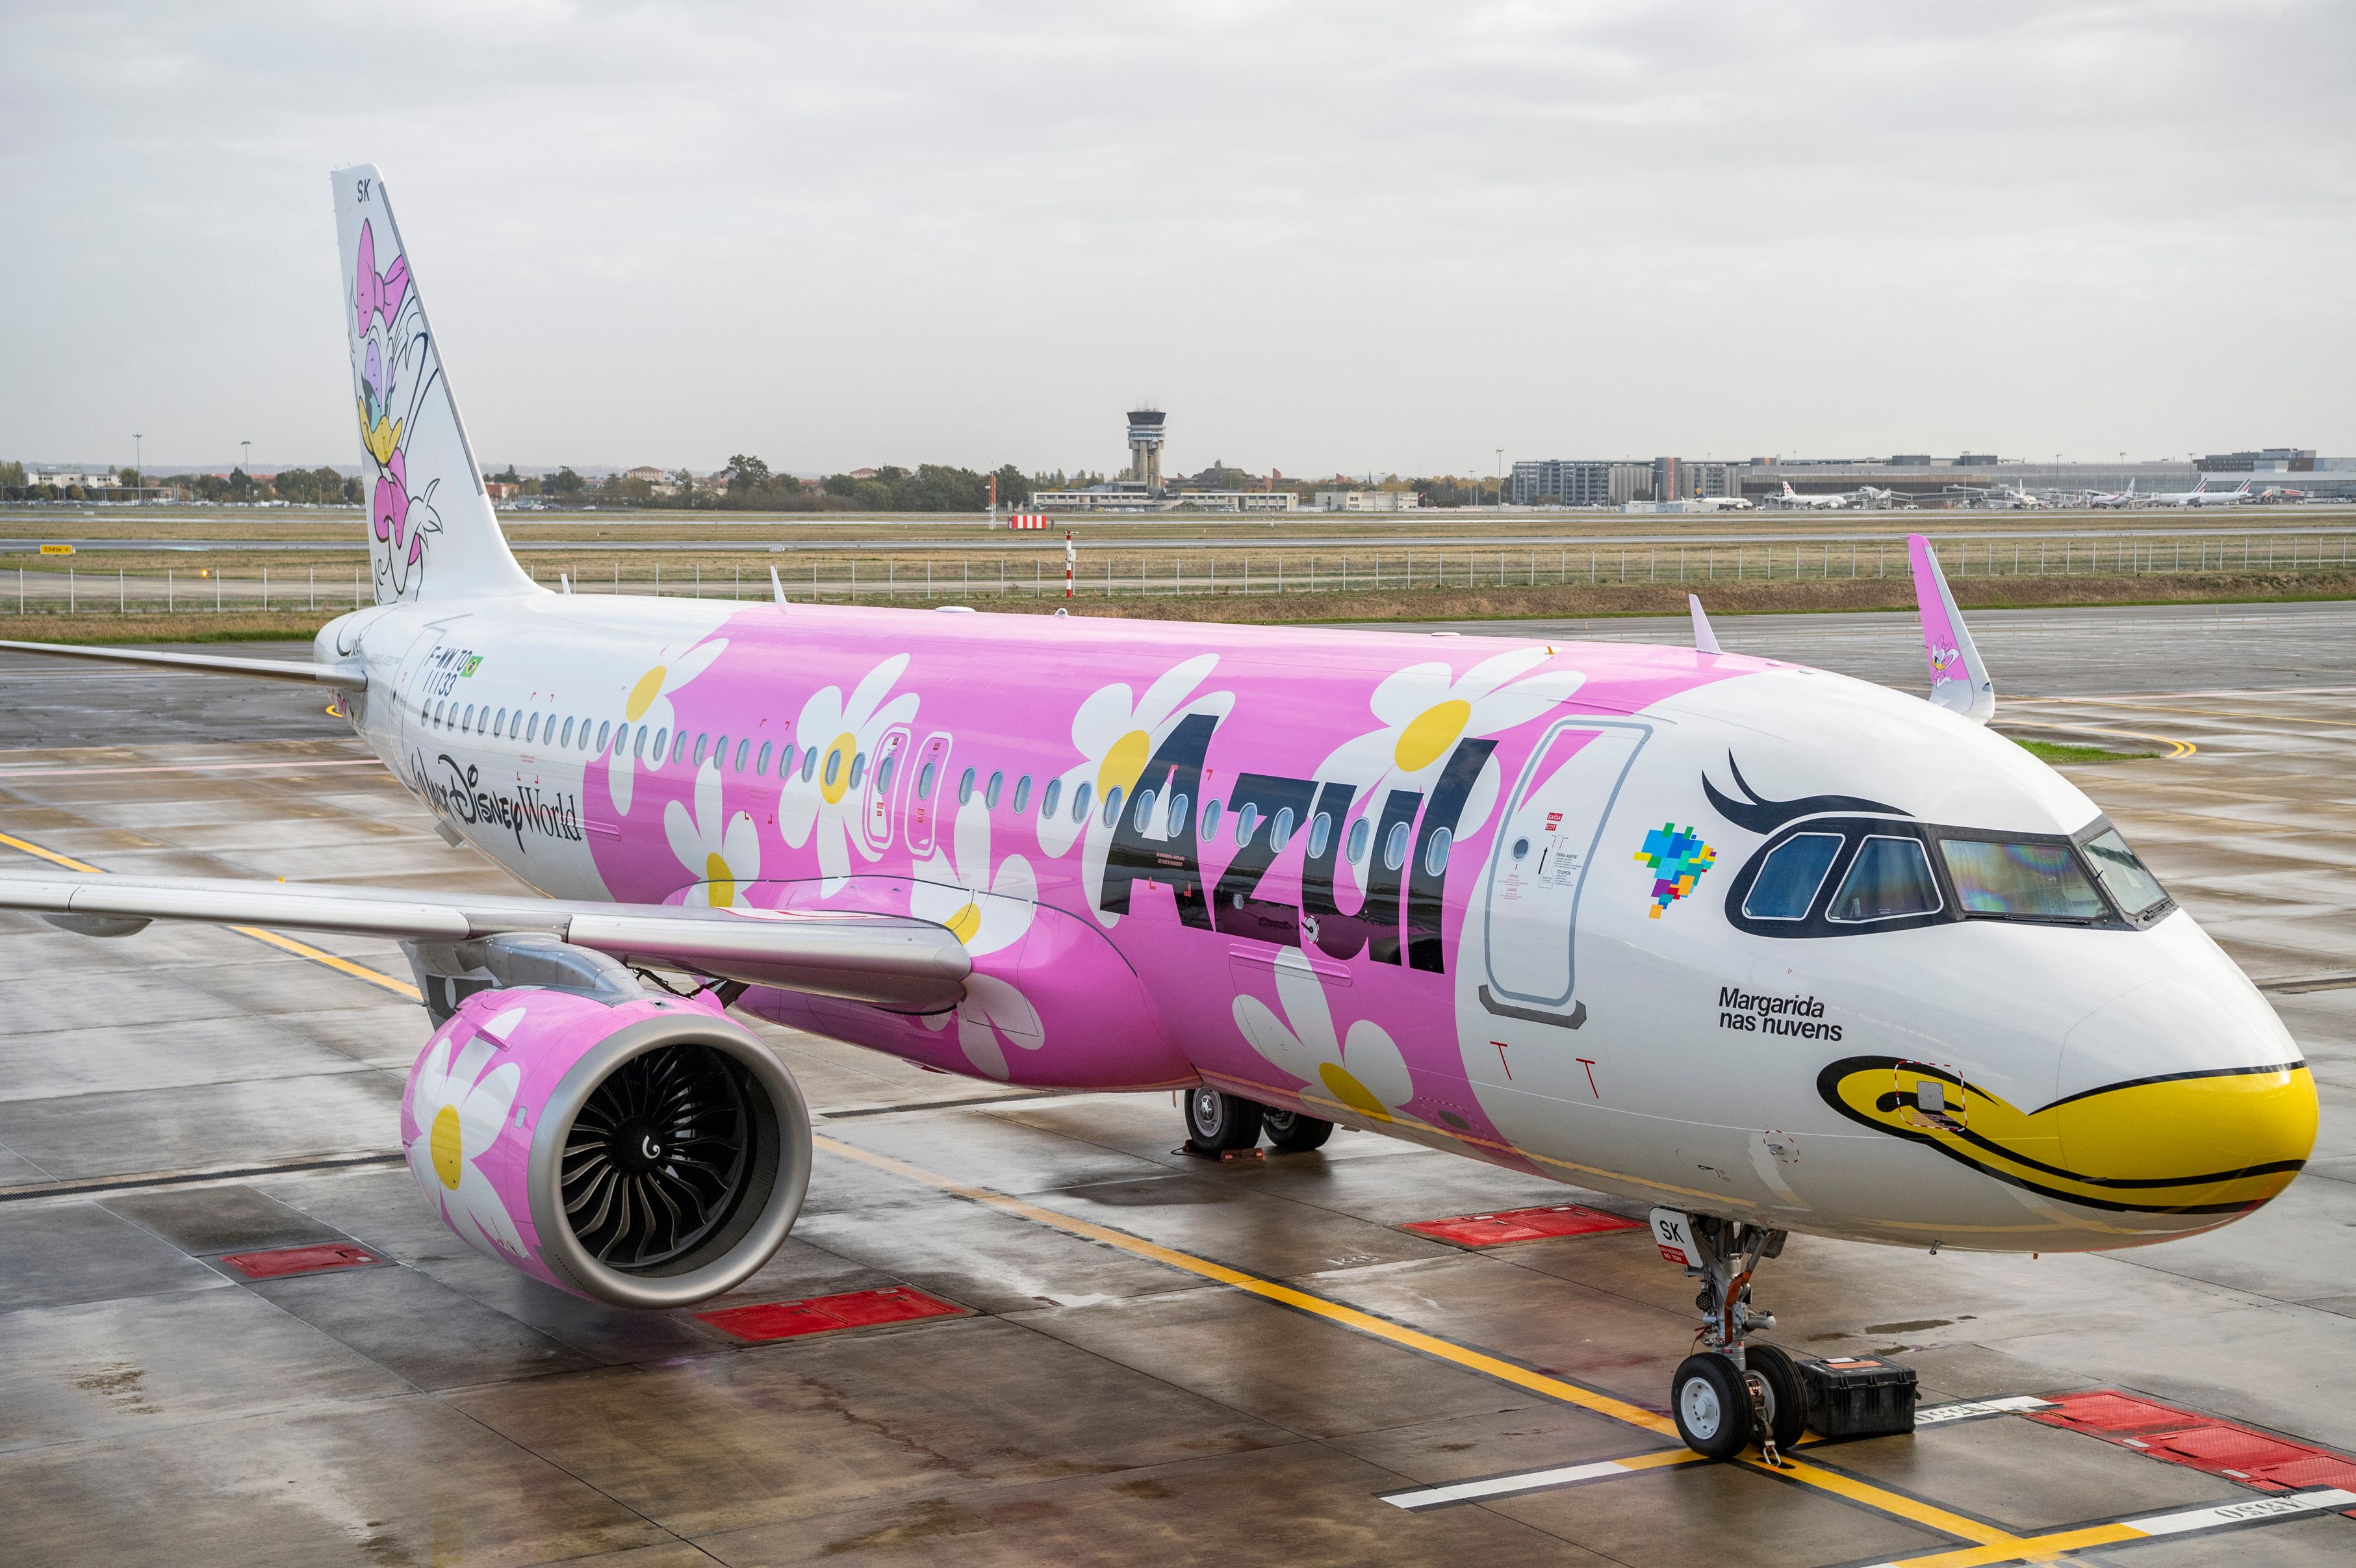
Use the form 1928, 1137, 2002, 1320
330, 162, 535, 604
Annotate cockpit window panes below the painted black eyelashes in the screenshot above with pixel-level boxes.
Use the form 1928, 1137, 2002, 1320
1743, 828, 2168, 924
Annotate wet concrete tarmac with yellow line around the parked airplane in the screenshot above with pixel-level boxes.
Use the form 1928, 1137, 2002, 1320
0, 606, 2356, 1568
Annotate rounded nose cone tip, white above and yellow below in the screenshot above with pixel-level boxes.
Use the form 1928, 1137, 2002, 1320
2047, 971, 2316, 1215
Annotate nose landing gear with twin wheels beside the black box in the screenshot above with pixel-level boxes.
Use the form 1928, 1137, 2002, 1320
1652, 1209, 1807, 1464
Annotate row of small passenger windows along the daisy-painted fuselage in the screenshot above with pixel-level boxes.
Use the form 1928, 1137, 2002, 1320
424, 698, 1452, 877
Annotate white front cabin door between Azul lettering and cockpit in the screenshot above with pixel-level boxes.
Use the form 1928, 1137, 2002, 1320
1479, 719, 1652, 1028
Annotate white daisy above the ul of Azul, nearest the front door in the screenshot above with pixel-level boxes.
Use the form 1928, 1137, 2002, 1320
1314, 649, 1588, 884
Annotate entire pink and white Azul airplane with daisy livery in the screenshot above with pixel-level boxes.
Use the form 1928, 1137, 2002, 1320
0, 165, 2316, 1455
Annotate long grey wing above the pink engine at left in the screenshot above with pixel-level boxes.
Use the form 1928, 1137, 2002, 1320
0, 875, 973, 1007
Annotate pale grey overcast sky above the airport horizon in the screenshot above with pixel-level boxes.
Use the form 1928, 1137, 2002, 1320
0, 0, 2356, 474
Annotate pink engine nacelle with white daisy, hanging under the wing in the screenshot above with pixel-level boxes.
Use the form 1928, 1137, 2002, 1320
400, 988, 810, 1306
